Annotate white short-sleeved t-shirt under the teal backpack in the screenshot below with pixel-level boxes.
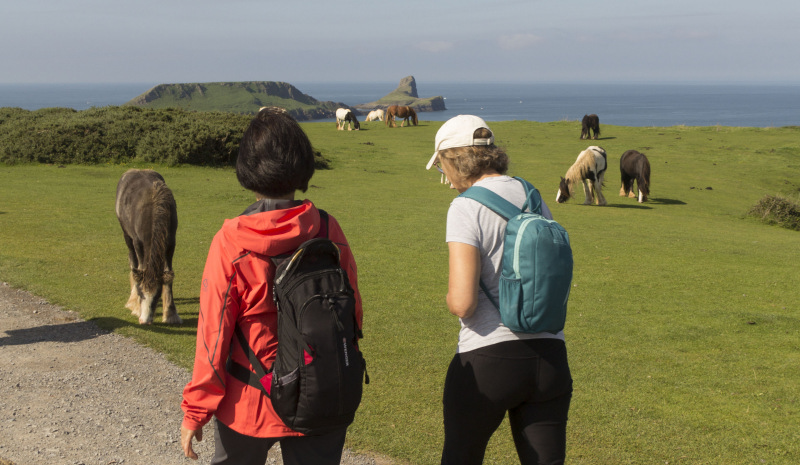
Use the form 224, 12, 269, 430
446, 176, 564, 352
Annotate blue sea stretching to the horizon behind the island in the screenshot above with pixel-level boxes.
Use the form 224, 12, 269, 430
0, 81, 800, 127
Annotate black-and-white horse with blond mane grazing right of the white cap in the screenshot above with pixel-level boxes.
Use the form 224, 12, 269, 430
556, 145, 607, 205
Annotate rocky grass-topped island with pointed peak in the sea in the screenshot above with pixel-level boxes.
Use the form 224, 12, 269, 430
125, 76, 445, 121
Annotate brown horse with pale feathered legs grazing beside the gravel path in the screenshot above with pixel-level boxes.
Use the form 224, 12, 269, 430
115, 169, 181, 324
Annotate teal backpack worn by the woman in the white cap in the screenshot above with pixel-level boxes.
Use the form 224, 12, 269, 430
459, 177, 573, 334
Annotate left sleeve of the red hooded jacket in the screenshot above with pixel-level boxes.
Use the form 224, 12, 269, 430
181, 233, 240, 430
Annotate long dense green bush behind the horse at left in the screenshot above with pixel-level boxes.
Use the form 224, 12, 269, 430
0, 106, 251, 166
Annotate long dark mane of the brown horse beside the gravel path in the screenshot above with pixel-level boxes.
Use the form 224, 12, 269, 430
142, 181, 175, 292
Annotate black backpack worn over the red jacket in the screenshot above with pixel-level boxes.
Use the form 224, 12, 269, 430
228, 211, 369, 435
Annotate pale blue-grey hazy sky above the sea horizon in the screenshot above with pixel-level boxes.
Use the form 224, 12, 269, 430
0, 0, 800, 83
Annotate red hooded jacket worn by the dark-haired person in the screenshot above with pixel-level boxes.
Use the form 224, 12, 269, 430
181, 200, 362, 438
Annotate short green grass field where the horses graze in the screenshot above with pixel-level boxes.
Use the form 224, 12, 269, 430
0, 121, 800, 464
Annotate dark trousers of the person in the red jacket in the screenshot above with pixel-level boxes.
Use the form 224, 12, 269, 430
211, 420, 347, 465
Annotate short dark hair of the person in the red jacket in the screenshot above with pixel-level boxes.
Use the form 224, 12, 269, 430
236, 107, 314, 198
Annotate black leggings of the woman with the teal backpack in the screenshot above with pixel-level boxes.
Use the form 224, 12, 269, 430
442, 339, 572, 465
